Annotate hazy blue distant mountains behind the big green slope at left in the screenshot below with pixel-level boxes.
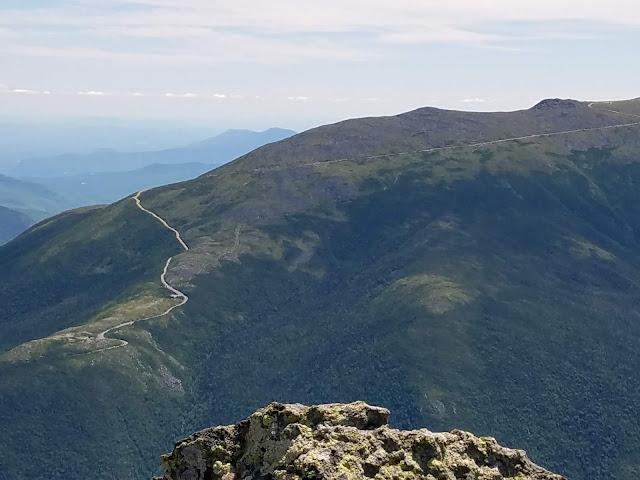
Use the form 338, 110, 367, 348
0, 128, 295, 244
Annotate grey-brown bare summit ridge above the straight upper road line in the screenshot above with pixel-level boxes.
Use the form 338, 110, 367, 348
222, 99, 640, 172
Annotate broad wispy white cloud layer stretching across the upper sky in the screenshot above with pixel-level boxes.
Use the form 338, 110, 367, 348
0, 0, 640, 70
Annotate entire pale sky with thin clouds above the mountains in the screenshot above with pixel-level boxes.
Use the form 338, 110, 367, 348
0, 0, 640, 130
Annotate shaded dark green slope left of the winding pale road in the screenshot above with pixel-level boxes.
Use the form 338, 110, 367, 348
0, 202, 175, 349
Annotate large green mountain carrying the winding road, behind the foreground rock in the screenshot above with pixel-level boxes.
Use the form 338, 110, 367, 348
0, 101, 640, 480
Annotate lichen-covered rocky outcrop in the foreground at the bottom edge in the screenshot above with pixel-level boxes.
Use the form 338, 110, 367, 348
158, 402, 563, 480
